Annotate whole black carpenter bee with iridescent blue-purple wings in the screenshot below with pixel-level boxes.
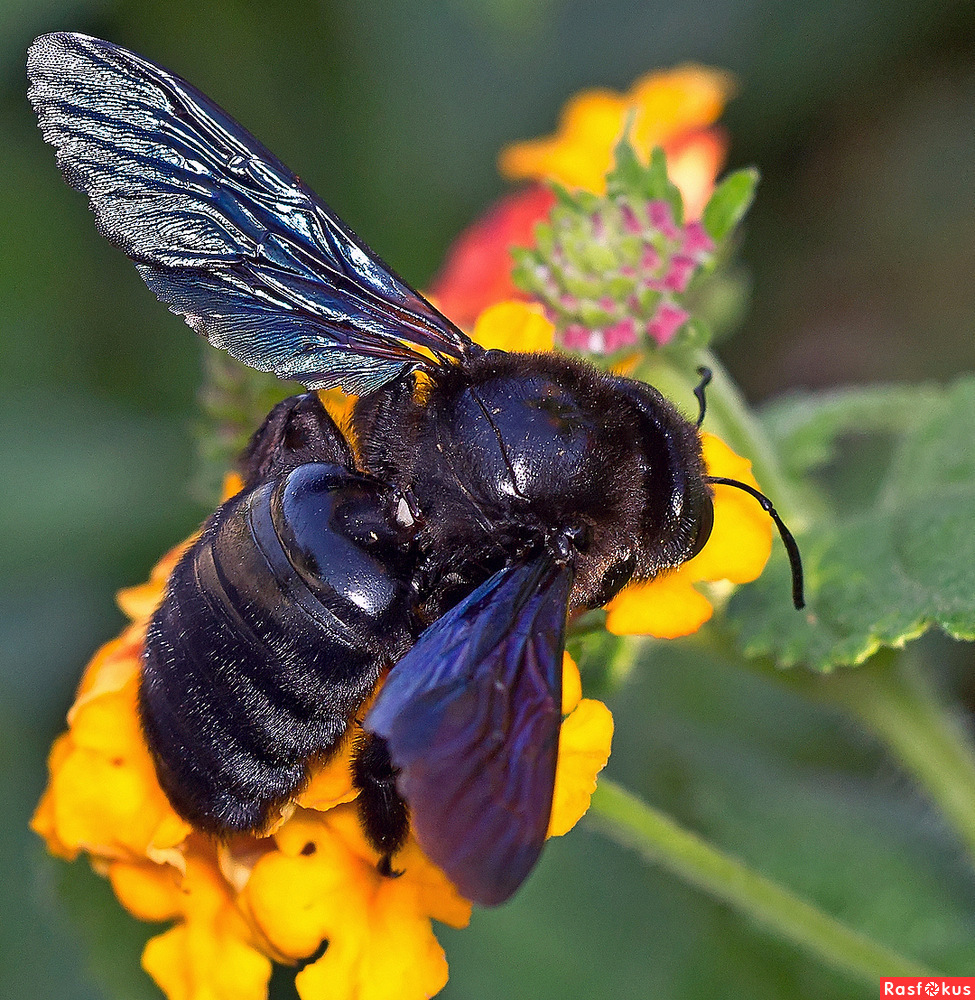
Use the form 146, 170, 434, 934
28, 33, 802, 904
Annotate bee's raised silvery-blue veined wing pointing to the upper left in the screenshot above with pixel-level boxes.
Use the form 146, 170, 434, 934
27, 32, 473, 393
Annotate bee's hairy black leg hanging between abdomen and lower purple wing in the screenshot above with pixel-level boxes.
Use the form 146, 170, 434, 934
352, 733, 410, 878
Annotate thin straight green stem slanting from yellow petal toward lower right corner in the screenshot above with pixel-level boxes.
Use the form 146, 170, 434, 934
589, 777, 931, 984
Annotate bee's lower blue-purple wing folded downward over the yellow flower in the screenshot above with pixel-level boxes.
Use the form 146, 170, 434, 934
364, 557, 572, 905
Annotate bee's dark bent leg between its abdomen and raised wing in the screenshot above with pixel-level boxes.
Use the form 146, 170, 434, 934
238, 392, 355, 485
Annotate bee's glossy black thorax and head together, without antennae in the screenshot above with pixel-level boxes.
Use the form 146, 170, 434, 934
438, 352, 712, 607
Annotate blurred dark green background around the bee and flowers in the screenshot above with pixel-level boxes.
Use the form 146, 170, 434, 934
0, 0, 975, 1000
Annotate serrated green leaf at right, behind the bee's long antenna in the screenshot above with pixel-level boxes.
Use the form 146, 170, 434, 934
728, 378, 975, 671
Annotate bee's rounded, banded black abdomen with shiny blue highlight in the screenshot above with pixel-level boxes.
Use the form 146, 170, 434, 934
141, 464, 412, 832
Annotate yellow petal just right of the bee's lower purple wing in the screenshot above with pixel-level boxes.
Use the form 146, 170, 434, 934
548, 698, 613, 837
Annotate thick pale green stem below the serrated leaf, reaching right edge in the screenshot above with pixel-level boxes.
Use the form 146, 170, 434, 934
810, 649, 975, 858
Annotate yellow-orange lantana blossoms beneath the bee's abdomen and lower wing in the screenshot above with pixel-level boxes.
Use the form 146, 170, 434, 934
31, 462, 612, 1000
